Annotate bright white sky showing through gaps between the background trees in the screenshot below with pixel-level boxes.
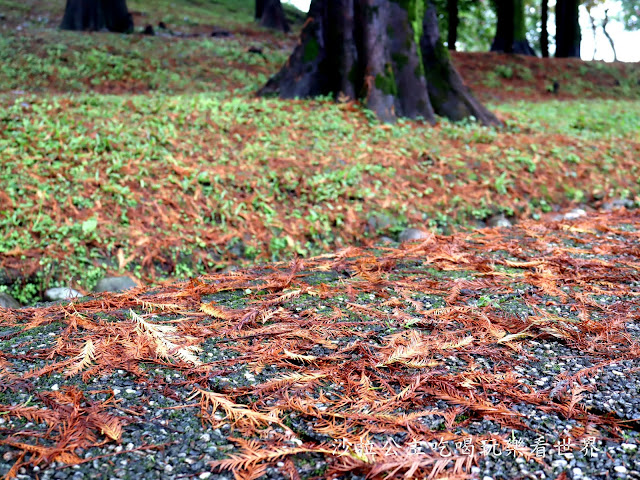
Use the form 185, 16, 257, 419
284, 0, 640, 62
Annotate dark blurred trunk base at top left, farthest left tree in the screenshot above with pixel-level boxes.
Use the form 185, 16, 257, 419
60, 0, 133, 33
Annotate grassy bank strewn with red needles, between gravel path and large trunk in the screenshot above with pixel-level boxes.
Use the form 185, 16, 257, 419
0, 92, 640, 304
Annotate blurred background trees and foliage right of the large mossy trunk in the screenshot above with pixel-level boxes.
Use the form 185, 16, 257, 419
418, 0, 640, 57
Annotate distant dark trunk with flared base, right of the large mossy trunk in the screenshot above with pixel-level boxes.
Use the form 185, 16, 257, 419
491, 0, 536, 56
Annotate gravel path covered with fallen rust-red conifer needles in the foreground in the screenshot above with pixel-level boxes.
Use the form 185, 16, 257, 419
0, 212, 640, 479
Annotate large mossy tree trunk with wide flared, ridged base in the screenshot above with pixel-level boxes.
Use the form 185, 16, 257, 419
258, 0, 499, 124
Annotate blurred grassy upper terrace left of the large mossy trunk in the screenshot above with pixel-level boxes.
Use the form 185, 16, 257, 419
0, 31, 286, 93
